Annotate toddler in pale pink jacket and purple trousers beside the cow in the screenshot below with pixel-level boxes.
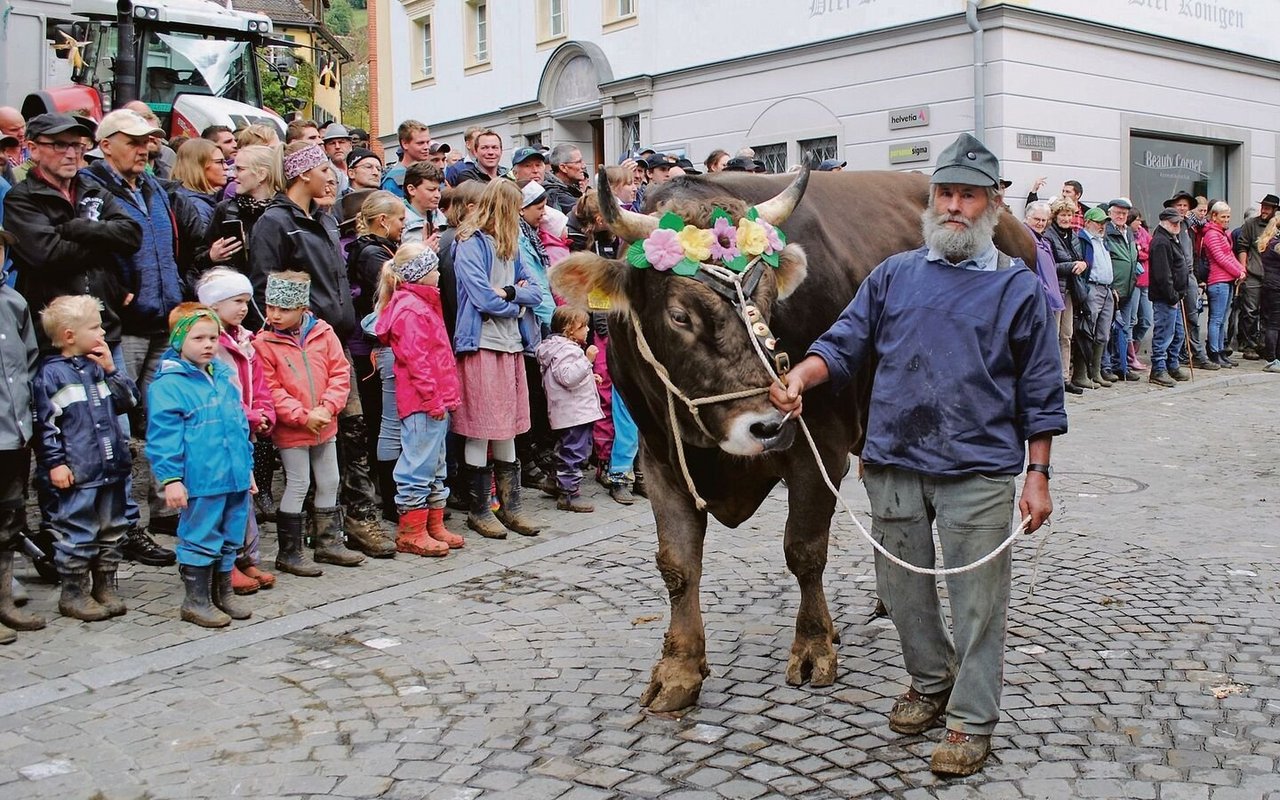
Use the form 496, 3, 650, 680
538, 306, 604, 512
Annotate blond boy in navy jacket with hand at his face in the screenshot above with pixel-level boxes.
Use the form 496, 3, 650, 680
32, 294, 138, 622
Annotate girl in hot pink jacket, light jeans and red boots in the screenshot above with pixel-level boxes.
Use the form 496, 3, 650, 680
374, 242, 465, 556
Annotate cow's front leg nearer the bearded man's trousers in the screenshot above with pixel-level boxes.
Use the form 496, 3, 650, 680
783, 453, 845, 686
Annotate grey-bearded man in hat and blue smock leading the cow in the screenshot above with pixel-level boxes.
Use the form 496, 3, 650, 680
771, 134, 1066, 774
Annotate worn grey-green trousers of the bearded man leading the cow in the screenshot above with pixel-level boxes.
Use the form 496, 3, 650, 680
864, 465, 1015, 736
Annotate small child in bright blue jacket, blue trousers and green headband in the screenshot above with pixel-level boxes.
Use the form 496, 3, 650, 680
147, 303, 253, 627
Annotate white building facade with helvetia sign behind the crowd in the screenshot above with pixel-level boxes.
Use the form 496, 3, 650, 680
383, 0, 1280, 215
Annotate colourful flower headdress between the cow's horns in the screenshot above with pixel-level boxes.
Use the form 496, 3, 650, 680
626, 206, 787, 278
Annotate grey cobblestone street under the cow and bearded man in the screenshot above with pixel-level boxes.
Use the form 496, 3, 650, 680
0, 365, 1280, 800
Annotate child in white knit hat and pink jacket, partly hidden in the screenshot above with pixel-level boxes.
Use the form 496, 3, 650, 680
196, 268, 275, 594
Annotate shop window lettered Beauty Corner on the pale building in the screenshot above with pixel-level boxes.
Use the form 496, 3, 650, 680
1129, 133, 1230, 220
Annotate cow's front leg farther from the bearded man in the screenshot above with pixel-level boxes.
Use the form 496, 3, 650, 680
640, 442, 710, 712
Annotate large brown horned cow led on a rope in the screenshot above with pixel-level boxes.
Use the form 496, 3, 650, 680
550, 170, 1036, 710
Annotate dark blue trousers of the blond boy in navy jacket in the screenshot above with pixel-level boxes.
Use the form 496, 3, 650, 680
49, 480, 129, 575
